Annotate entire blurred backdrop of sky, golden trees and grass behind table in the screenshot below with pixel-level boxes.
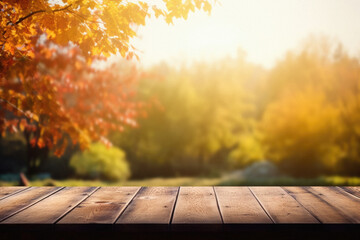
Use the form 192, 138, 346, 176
0, 0, 360, 186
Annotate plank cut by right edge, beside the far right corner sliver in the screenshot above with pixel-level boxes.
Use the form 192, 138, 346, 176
306, 187, 360, 223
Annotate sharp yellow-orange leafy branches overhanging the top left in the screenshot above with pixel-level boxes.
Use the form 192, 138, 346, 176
0, 0, 211, 57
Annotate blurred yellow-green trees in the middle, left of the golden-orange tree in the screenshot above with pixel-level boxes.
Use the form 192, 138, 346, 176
112, 56, 261, 177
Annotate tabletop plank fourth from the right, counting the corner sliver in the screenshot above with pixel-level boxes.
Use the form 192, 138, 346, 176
250, 187, 319, 223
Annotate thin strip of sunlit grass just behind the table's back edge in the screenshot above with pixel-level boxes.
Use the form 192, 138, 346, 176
0, 176, 360, 186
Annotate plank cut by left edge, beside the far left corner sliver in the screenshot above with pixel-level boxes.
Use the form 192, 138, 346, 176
0, 187, 60, 222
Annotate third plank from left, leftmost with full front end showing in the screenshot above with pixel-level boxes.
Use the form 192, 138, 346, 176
2, 187, 97, 224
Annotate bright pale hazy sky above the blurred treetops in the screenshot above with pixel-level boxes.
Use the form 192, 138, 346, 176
129, 0, 360, 67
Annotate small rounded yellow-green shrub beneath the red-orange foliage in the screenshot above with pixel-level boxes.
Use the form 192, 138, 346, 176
70, 143, 130, 181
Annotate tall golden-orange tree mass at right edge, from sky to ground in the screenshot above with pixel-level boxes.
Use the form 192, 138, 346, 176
261, 38, 360, 176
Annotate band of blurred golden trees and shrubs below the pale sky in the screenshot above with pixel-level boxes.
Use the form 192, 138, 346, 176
0, 37, 360, 180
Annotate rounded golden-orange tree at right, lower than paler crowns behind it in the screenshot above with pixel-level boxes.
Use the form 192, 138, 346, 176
261, 89, 343, 177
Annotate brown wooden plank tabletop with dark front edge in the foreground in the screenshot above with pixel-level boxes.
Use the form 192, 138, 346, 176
0, 187, 360, 239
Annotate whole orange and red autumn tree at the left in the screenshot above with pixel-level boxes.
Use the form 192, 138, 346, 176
0, 0, 211, 173
